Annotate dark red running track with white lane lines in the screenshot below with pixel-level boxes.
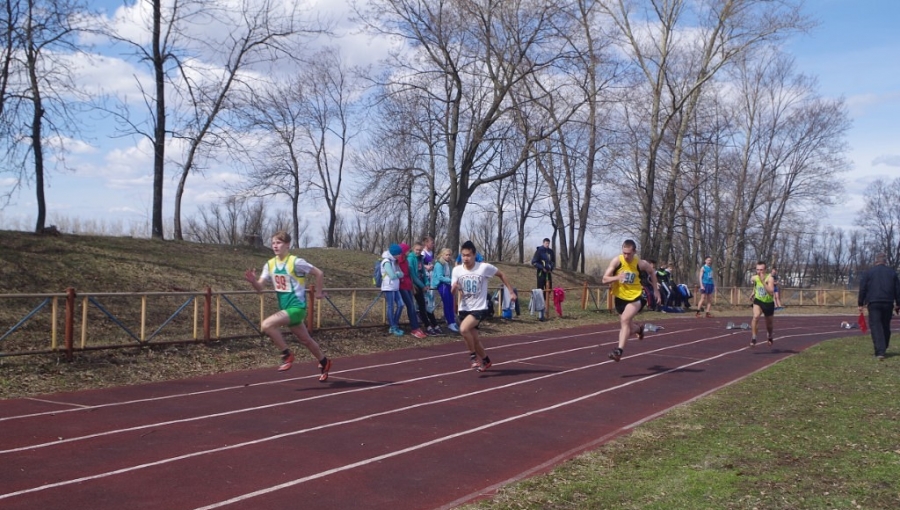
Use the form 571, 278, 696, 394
0, 315, 859, 510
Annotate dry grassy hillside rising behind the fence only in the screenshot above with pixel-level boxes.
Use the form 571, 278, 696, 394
0, 231, 595, 294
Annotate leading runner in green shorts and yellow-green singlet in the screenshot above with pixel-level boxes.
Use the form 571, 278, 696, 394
244, 231, 331, 382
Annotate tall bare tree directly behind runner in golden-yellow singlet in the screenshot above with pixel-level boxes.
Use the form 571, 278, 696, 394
601, 0, 806, 258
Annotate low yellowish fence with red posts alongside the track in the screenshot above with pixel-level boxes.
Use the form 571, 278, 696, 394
0, 284, 856, 358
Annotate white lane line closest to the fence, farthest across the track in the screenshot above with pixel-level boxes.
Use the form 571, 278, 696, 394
0, 329, 618, 422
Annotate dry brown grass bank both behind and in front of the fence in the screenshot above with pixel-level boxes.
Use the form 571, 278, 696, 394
0, 231, 612, 398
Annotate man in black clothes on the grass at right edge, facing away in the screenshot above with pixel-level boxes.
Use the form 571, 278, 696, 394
857, 253, 900, 361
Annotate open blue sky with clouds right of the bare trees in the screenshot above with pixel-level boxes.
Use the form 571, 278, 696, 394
787, 0, 900, 228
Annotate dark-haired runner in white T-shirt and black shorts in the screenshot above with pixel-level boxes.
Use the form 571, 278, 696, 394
450, 241, 517, 372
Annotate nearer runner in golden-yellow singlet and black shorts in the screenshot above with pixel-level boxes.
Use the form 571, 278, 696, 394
603, 239, 660, 361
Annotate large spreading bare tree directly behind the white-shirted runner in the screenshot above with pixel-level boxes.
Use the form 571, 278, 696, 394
358, 0, 560, 253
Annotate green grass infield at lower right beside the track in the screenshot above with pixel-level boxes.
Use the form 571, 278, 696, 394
466, 337, 900, 510
